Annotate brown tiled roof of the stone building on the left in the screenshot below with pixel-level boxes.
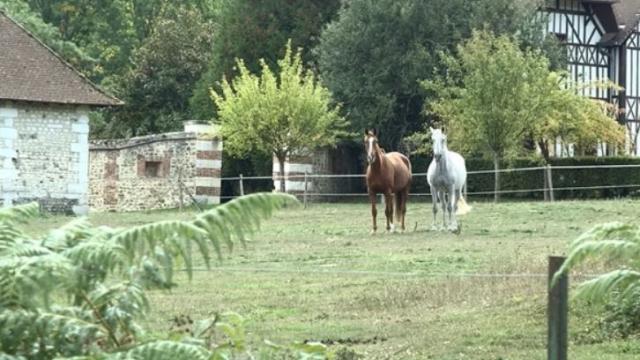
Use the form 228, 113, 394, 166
0, 11, 122, 106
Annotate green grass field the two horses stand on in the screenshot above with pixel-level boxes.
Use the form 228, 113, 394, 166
34, 200, 640, 359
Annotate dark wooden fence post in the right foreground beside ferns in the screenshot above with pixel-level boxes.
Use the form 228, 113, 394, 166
547, 256, 569, 360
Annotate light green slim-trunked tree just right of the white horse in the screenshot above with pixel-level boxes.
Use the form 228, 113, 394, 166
423, 32, 549, 200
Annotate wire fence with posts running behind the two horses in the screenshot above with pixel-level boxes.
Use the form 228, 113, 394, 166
216, 164, 640, 201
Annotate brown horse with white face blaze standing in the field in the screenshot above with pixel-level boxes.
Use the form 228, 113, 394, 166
364, 130, 411, 233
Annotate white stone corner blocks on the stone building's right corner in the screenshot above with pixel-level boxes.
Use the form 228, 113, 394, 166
65, 112, 89, 215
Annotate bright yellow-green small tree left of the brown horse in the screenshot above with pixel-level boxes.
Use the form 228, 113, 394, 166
211, 42, 346, 191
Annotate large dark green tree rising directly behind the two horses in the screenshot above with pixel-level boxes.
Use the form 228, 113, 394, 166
317, 0, 553, 148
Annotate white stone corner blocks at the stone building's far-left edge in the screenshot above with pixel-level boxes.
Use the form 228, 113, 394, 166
0, 107, 18, 206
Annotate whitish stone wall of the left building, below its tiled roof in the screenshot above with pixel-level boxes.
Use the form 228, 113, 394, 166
0, 101, 89, 214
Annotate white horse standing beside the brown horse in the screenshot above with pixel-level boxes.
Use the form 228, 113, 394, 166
427, 128, 471, 232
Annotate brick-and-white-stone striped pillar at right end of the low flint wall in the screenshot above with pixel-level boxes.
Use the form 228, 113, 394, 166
184, 121, 222, 204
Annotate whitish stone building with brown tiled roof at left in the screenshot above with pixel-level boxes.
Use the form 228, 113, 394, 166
0, 12, 121, 213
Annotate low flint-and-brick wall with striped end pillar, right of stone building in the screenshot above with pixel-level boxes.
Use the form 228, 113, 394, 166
89, 123, 222, 211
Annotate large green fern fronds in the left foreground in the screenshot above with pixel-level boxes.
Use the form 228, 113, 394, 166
0, 194, 332, 359
